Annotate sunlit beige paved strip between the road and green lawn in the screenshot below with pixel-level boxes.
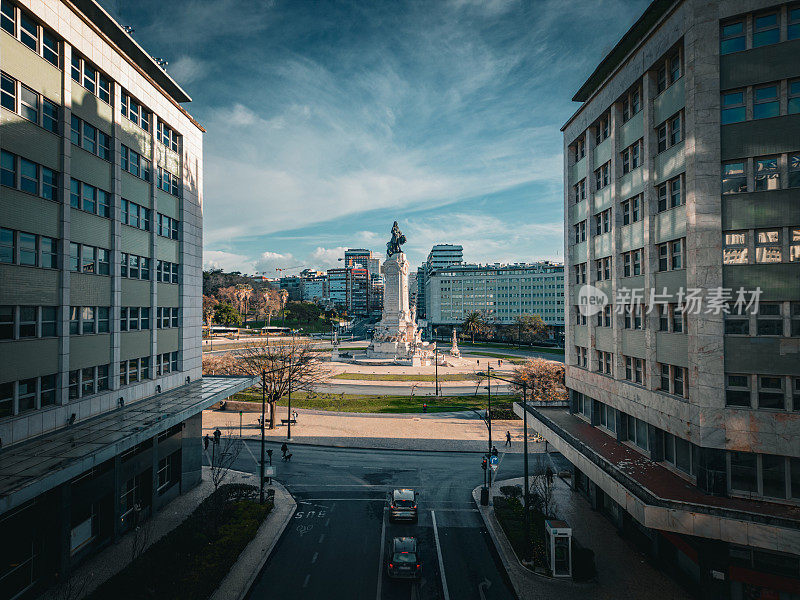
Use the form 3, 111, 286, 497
203, 409, 544, 453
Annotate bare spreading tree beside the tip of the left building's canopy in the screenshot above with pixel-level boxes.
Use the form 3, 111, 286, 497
212, 338, 327, 429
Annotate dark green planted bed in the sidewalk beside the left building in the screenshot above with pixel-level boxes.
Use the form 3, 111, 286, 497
88, 484, 273, 600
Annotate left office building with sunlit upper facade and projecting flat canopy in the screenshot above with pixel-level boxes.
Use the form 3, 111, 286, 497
0, 0, 250, 598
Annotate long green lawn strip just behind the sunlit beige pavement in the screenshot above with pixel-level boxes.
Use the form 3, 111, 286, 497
231, 388, 518, 419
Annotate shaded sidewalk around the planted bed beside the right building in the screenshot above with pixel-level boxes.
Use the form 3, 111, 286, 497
472, 477, 690, 600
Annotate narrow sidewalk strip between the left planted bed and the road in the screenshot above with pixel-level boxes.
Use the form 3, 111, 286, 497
209, 479, 297, 600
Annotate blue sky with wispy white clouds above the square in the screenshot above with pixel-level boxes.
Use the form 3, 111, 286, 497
100, 0, 647, 277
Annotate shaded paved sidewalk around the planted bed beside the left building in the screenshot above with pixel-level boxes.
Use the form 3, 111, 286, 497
39, 467, 297, 600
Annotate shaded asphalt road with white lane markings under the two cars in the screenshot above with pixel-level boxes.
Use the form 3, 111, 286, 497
225, 442, 549, 600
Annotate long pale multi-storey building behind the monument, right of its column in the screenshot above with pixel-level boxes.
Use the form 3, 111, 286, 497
425, 262, 564, 332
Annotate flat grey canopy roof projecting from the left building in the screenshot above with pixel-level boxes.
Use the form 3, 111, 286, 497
0, 377, 253, 514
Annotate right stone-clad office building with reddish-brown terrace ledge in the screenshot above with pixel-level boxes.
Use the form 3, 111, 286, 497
528, 0, 800, 599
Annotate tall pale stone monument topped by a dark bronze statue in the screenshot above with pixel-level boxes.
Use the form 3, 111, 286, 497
367, 221, 434, 366
